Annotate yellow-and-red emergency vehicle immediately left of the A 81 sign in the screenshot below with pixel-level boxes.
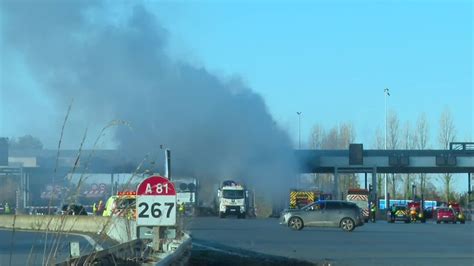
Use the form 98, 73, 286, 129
102, 191, 137, 219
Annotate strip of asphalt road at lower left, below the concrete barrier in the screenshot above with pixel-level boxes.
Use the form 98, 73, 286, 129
0, 229, 93, 266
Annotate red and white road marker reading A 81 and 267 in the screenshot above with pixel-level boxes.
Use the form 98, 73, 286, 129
136, 176, 176, 226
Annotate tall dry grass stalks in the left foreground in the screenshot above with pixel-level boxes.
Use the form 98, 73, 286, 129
9, 101, 184, 265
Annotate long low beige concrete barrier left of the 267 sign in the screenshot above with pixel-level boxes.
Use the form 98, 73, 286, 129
0, 215, 136, 243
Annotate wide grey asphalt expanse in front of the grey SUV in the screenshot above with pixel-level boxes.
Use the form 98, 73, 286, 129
186, 217, 474, 265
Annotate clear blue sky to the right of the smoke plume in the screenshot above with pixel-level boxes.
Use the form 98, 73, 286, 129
149, 1, 474, 147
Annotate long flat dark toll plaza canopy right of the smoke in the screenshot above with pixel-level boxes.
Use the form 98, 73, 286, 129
295, 142, 474, 201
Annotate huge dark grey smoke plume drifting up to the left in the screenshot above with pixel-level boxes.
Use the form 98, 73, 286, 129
0, 0, 293, 197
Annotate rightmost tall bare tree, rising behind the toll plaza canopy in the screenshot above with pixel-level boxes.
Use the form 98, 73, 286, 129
438, 108, 456, 201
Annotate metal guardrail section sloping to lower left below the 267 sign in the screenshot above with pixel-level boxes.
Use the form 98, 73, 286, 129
56, 239, 151, 266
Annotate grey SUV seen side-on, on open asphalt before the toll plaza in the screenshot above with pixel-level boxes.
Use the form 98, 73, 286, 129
280, 200, 364, 232
